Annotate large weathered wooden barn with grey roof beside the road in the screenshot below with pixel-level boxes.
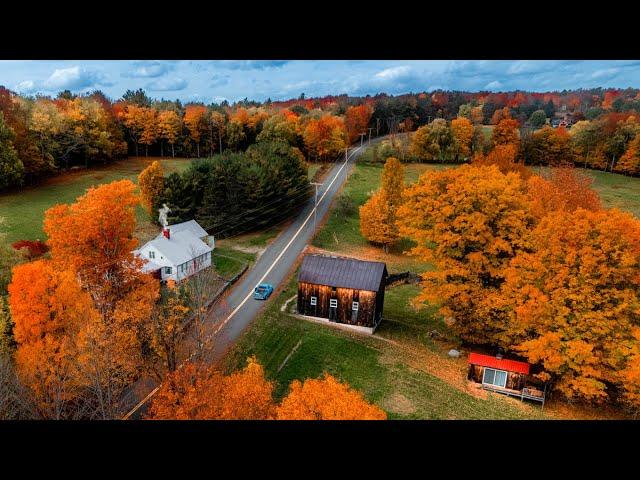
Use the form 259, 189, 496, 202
298, 255, 388, 332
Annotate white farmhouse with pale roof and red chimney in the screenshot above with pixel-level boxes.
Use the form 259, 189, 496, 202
133, 220, 215, 282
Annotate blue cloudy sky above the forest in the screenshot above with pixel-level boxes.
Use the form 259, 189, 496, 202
0, 60, 640, 103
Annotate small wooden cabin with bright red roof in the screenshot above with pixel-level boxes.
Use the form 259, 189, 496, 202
467, 352, 546, 408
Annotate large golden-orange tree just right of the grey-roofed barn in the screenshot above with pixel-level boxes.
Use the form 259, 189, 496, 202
398, 165, 534, 343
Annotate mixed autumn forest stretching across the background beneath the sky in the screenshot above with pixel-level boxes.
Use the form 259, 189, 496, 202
0, 87, 640, 189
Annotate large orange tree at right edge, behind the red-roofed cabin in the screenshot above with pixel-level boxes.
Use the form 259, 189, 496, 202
498, 208, 640, 406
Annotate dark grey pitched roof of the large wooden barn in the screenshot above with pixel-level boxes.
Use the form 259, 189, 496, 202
298, 255, 388, 292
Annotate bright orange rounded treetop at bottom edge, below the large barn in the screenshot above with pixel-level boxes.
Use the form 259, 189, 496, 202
277, 374, 387, 420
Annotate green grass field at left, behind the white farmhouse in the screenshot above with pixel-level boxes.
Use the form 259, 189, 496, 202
0, 157, 191, 242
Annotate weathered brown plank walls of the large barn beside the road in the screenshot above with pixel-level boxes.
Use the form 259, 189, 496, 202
298, 282, 384, 327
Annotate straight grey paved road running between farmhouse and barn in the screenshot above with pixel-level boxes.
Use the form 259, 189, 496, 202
125, 137, 382, 419
